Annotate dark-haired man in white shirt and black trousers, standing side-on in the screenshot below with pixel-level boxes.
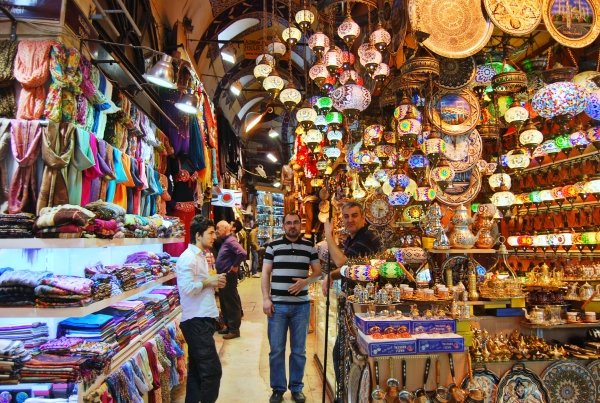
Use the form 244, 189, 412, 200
177, 215, 226, 403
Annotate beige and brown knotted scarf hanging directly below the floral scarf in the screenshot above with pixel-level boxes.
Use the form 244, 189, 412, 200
37, 121, 75, 214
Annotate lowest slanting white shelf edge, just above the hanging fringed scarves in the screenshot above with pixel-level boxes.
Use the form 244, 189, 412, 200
77, 306, 181, 403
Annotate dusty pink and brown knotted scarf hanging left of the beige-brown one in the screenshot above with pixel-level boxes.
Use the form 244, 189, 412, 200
8, 119, 42, 214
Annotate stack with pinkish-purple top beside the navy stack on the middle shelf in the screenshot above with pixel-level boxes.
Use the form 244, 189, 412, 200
35, 275, 94, 308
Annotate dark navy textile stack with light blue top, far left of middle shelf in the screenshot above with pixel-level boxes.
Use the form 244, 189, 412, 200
0, 267, 53, 306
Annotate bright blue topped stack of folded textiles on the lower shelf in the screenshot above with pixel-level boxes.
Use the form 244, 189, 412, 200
56, 313, 117, 344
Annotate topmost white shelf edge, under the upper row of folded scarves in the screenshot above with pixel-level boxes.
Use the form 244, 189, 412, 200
0, 238, 185, 249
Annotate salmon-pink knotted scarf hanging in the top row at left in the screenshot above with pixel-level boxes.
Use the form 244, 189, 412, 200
15, 41, 52, 119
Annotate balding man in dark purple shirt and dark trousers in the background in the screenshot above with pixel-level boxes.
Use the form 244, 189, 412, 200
215, 221, 246, 340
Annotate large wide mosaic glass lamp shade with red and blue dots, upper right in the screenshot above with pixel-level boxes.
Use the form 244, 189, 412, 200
531, 81, 588, 119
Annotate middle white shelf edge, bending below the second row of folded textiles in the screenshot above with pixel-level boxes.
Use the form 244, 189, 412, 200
2, 273, 176, 318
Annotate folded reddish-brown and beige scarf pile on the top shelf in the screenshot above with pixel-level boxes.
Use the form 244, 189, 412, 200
33, 204, 95, 238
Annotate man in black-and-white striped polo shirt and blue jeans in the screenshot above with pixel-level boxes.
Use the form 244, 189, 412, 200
261, 213, 321, 403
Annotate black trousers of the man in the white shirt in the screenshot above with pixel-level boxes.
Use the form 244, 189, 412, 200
180, 318, 222, 403
